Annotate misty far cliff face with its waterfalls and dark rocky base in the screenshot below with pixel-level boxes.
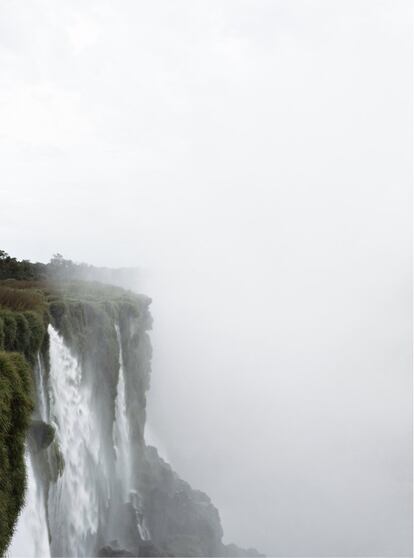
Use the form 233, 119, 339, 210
3, 282, 258, 556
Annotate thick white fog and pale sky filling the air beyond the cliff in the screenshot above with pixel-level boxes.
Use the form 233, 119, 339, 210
0, 0, 412, 556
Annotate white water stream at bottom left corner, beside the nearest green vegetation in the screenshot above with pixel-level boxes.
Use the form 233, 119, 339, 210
7, 451, 50, 558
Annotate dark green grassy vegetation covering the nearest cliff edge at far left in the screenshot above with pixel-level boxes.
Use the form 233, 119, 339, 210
0, 281, 48, 555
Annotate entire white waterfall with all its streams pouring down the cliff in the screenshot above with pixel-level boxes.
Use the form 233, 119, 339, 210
10, 325, 150, 558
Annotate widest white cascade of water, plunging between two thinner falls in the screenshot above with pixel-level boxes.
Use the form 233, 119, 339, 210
48, 326, 99, 556
